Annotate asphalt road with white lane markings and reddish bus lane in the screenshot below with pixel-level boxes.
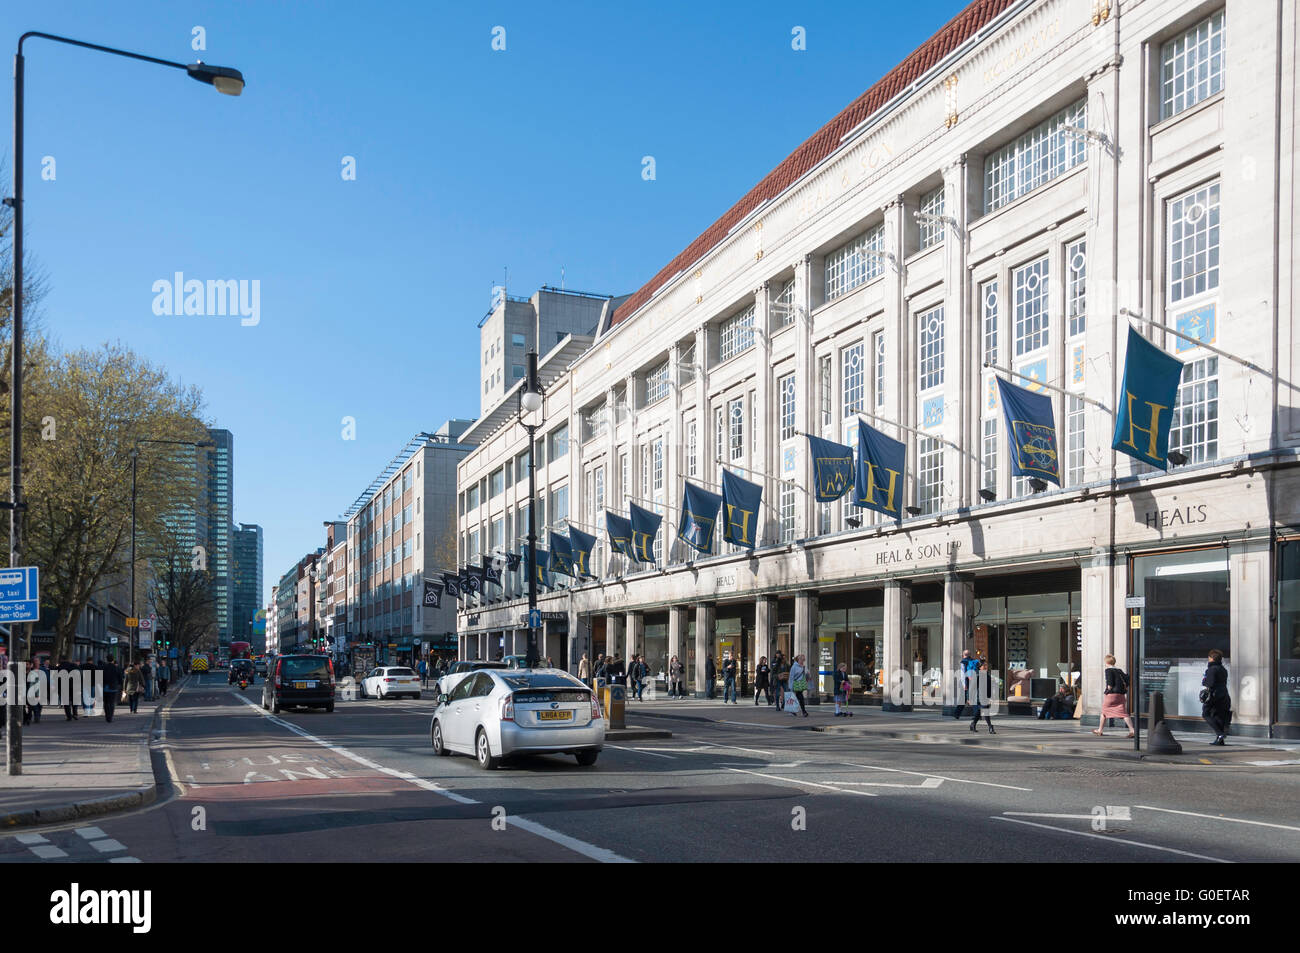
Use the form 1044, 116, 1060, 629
0, 673, 1300, 865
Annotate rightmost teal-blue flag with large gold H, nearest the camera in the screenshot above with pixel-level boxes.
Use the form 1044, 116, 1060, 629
1110, 325, 1183, 469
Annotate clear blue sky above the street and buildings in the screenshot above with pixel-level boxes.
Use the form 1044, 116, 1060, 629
0, 0, 965, 598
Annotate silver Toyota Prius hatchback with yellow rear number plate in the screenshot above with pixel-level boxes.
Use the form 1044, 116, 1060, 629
429, 668, 605, 770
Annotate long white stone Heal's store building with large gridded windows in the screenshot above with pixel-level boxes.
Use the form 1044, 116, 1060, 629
458, 0, 1300, 736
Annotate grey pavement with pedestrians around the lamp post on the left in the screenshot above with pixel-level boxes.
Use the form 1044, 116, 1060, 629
0, 683, 183, 831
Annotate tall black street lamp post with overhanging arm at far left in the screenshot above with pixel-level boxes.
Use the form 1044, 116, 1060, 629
3, 31, 244, 775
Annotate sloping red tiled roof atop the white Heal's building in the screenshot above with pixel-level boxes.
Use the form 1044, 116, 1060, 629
612, 0, 1015, 324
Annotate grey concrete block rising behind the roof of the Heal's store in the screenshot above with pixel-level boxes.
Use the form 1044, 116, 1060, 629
478, 287, 624, 413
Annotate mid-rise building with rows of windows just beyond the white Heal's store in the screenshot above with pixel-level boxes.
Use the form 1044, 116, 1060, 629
334, 420, 469, 660
